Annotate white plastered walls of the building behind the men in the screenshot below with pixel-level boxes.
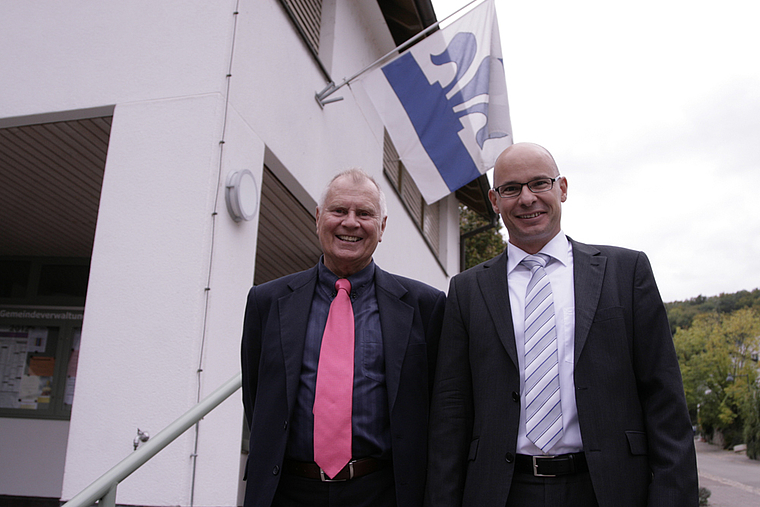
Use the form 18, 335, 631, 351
0, 0, 458, 506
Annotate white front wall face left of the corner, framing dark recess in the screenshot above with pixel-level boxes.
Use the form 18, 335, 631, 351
0, 1, 240, 504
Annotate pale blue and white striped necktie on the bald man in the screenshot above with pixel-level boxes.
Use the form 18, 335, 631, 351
522, 254, 562, 453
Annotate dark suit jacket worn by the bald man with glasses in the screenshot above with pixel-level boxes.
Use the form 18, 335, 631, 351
426, 240, 698, 507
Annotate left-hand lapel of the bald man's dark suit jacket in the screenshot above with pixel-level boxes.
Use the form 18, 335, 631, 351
476, 254, 519, 366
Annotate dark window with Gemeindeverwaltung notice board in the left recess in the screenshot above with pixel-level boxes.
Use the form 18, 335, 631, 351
0, 257, 90, 419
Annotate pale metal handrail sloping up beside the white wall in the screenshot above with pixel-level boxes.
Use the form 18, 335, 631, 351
63, 373, 243, 507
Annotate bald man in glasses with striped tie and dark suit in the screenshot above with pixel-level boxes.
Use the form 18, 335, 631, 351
427, 143, 698, 507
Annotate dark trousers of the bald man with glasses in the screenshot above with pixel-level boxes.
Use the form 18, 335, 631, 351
506, 472, 599, 507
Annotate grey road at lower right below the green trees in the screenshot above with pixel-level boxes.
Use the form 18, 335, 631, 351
694, 441, 760, 507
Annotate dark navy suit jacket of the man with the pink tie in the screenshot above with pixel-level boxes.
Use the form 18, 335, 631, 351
242, 266, 445, 507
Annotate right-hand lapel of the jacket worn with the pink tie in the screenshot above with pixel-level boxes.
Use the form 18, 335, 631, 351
375, 266, 414, 411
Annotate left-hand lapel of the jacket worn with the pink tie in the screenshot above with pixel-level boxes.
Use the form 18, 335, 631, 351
277, 266, 317, 407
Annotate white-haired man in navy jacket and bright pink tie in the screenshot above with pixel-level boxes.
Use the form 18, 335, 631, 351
242, 169, 445, 507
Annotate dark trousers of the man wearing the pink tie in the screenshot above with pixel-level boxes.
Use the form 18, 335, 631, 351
272, 467, 396, 507
